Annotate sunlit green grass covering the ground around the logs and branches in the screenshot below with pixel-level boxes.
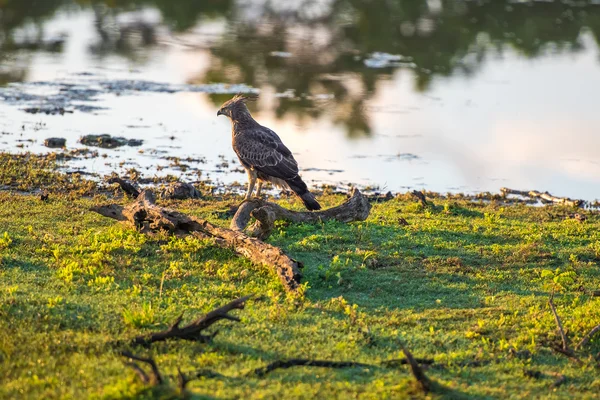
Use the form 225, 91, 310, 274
0, 155, 600, 399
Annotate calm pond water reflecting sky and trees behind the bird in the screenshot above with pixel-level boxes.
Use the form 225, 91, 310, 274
0, 0, 600, 200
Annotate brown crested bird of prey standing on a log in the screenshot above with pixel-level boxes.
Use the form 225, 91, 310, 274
217, 94, 321, 211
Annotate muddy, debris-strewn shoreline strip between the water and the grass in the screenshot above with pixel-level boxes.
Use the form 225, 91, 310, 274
0, 149, 600, 210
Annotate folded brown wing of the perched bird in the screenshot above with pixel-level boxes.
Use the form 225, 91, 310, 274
233, 126, 298, 180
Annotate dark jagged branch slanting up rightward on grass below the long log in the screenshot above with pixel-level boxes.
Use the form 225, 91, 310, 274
133, 296, 251, 345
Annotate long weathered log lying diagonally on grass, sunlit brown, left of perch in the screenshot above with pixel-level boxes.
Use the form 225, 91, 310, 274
91, 190, 302, 290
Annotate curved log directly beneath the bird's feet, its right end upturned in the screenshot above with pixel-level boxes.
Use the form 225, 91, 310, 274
230, 188, 371, 240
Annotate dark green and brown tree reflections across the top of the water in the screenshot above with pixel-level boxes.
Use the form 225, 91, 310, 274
0, 0, 600, 94
